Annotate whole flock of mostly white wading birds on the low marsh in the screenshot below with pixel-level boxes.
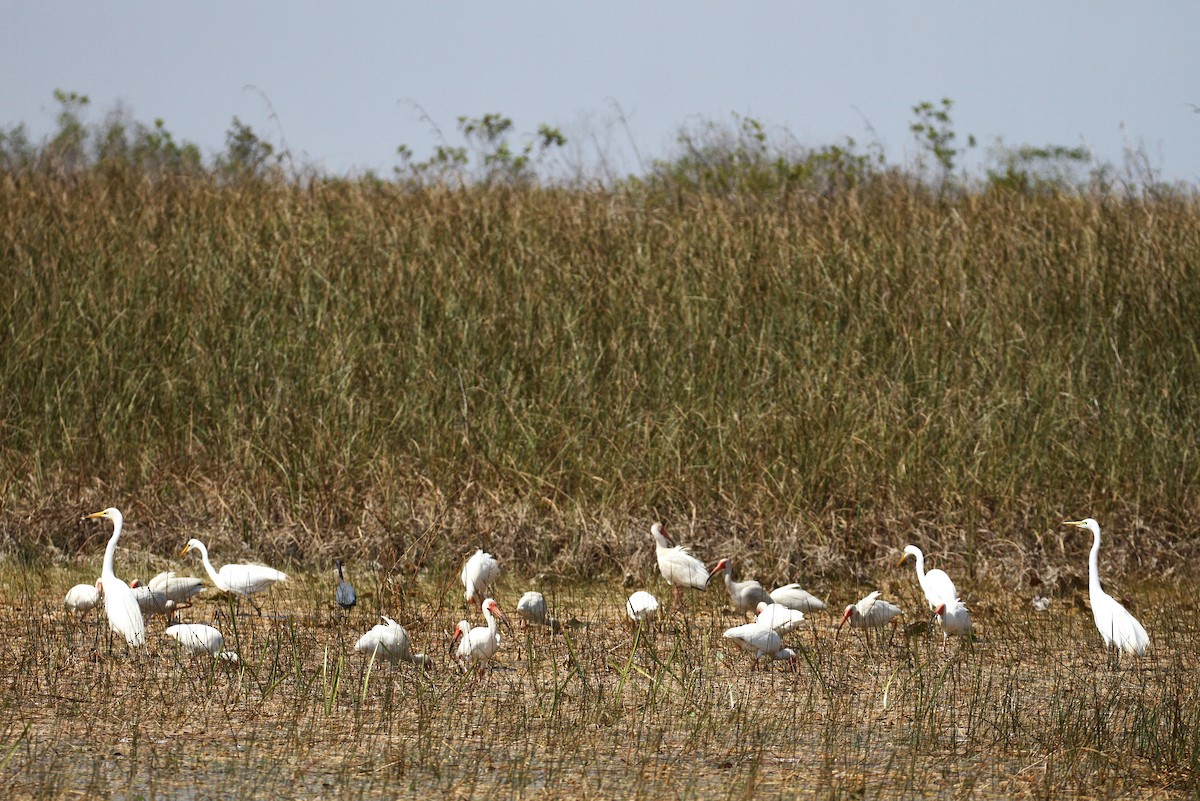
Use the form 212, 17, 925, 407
65, 508, 1150, 675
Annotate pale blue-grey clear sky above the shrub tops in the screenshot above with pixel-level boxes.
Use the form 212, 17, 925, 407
0, 0, 1200, 182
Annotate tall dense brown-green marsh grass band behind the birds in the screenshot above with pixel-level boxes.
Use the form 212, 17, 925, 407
0, 170, 1200, 574
